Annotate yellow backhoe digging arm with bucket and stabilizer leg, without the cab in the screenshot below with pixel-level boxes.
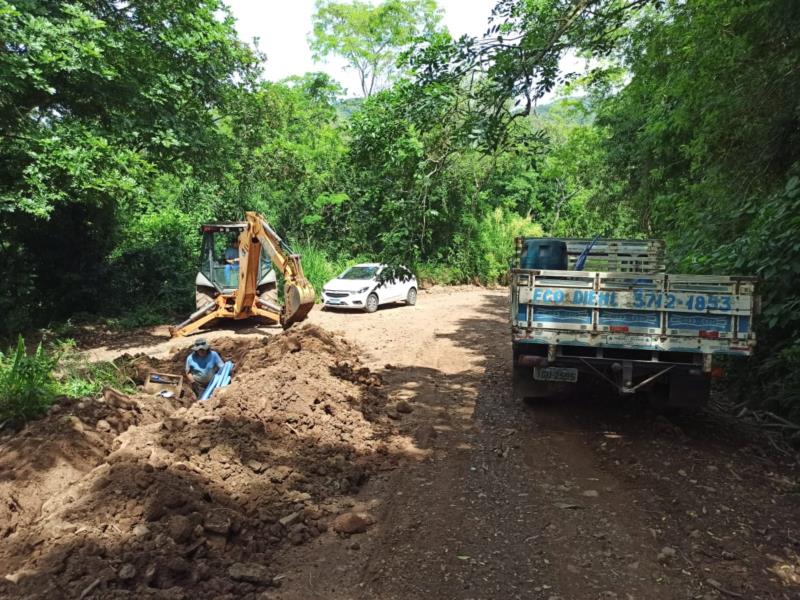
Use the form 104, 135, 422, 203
170, 212, 315, 337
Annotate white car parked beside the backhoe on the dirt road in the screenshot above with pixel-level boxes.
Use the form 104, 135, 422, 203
322, 263, 417, 312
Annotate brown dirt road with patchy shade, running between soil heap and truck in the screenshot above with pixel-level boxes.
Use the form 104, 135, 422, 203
282, 290, 800, 600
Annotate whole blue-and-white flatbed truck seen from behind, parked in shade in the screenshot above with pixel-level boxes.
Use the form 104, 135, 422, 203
509, 238, 758, 407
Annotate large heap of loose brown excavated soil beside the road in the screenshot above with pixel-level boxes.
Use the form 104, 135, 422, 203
0, 325, 396, 598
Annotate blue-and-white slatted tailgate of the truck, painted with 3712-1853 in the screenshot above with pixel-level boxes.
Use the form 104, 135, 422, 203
511, 269, 756, 360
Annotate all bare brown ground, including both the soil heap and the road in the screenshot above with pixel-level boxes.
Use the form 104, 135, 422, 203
0, 288, 800, 600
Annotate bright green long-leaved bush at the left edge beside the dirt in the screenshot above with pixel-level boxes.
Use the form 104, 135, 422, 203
0, 336, 58, 423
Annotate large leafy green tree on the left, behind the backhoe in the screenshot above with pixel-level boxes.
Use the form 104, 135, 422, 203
0, 0, 258, 328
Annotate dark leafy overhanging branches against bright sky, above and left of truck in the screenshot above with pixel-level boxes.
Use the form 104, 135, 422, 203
408, 0, 660, 147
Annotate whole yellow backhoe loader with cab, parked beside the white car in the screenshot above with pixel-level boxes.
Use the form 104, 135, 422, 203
170, 212, 314, 337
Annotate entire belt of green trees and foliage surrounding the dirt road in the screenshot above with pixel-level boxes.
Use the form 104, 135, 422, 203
0, 0, 800, 407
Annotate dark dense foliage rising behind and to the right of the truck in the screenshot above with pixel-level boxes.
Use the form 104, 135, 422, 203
598, 0, 800, 410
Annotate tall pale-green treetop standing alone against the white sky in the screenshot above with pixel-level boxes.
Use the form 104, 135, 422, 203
310, 0, 441, 97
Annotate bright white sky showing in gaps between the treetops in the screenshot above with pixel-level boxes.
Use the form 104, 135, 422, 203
226, 0, 496, 96
